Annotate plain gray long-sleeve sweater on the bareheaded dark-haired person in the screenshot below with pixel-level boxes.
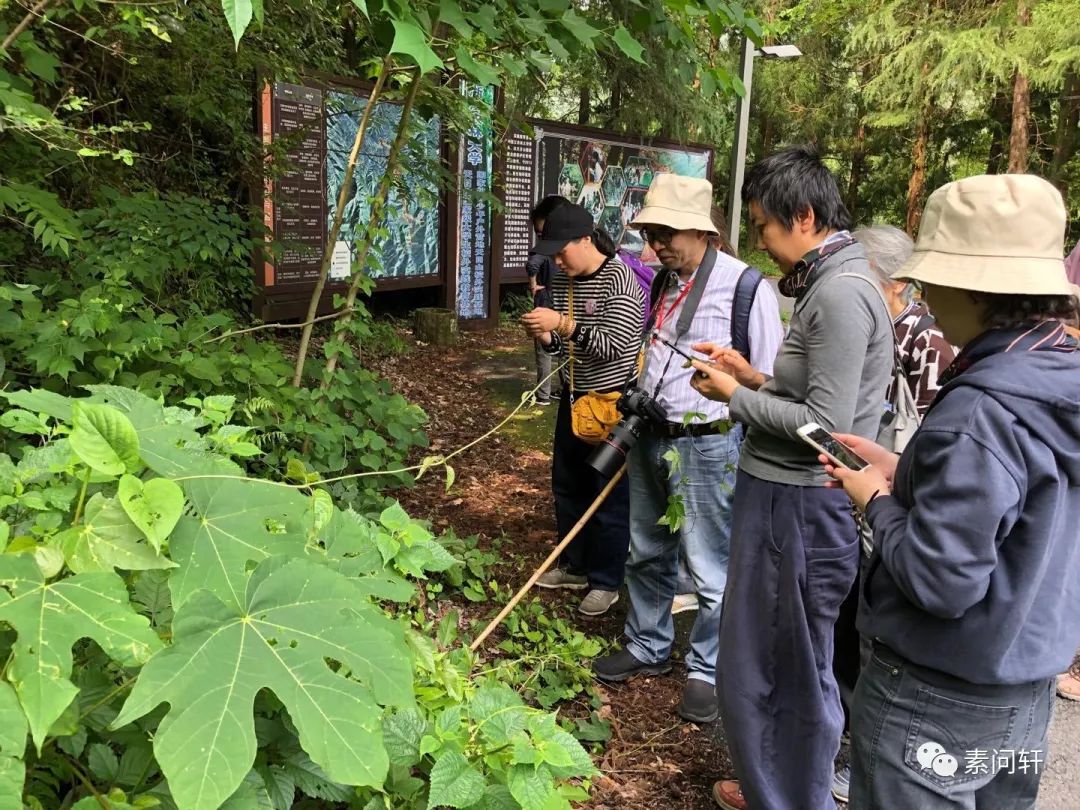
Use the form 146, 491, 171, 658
731, 244, 894, 486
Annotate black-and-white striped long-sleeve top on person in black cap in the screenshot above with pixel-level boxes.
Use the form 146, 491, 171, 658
546, 258, 645, 392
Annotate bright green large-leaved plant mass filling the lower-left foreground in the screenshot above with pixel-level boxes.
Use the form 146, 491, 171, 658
0, 386, 594, 810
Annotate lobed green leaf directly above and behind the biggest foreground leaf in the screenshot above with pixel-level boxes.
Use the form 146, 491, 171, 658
168, 478, 308, 609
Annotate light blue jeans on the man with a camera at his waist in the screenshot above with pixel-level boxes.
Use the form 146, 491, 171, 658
626, 430, 739, 684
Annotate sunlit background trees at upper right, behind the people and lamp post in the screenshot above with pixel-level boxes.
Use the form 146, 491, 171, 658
533, 0, 1080, 240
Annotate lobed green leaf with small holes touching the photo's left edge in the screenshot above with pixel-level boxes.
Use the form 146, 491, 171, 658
0, 554, 161, 748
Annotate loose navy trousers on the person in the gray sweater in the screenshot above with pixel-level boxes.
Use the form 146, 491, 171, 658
716, 472, 860, 810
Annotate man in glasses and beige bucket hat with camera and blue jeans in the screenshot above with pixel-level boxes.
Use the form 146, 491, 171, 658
593, 174, 783, 723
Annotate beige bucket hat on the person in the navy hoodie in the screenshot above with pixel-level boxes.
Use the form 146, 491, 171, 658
892, 174, 1072, 295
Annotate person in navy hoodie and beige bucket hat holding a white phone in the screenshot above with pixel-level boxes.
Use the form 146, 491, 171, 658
821, 175, 1080, 810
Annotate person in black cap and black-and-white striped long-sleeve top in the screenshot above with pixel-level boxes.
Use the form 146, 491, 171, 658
522, 204, 645, 616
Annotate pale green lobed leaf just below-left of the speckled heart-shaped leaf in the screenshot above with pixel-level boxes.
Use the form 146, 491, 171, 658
59, 494, 176, 573
